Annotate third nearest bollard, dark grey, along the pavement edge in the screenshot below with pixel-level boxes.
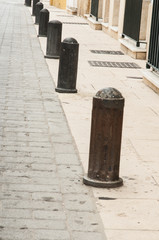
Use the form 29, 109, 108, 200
45, 20, 62, 59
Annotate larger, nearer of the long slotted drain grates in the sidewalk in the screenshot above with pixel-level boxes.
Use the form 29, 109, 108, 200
88, 61, 141, 68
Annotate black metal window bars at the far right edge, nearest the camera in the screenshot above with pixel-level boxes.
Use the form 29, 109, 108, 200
147, 0, 159, 71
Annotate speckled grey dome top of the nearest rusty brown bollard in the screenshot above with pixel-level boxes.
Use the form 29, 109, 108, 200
95, 87, 123, 100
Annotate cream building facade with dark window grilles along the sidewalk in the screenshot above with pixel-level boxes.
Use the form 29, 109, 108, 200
49, 0, 159, 92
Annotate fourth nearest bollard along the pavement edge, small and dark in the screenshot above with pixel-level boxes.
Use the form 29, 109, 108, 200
38, 9, 49, 37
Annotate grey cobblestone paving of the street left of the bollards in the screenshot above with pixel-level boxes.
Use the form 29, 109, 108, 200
0, 0, 105, 240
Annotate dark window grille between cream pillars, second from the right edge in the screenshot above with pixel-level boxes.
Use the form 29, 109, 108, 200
123, 0, 143, 42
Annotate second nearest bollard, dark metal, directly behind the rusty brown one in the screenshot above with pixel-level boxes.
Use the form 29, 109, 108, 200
55, 38, 79, 93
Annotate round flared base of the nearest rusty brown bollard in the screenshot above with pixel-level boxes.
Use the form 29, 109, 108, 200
83, 176, 123, 188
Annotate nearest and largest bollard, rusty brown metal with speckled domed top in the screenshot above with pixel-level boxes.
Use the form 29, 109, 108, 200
83, 88, 124, 188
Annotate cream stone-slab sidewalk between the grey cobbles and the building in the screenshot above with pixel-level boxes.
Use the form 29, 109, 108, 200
33, 1, 159, 240
